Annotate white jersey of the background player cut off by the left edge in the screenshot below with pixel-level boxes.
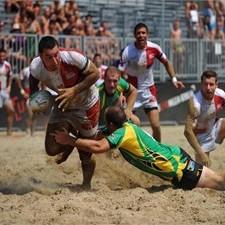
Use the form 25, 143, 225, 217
0, 61, 12, 90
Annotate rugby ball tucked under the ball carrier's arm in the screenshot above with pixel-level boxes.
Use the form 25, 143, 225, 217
29, 90, 53, 113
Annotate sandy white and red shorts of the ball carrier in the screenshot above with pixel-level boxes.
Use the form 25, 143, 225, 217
49, 101, 100, 138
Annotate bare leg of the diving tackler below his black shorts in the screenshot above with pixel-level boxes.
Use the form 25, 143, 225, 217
196, 166, 225, 191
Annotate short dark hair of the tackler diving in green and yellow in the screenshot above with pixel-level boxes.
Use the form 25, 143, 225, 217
105, 106, 127, 128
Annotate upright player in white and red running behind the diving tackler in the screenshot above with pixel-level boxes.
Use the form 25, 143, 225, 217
119, 23, 184, 141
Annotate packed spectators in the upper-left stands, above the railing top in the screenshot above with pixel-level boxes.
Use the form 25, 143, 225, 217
5, 0, 113, 37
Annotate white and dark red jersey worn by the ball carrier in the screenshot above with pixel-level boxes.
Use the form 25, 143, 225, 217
30, 49, 98, 109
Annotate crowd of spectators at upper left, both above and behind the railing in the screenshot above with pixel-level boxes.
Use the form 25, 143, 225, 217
2, 0, 120, 70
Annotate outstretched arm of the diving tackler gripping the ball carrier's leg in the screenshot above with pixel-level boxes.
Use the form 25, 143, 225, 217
51, 129, 110, 153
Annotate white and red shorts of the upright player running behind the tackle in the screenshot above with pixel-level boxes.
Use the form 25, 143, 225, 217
134, 85, 158, 110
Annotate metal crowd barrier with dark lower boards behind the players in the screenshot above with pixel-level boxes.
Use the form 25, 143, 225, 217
0, 34, 225, 129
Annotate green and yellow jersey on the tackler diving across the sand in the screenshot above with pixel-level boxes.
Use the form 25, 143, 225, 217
106, 122, 187, 181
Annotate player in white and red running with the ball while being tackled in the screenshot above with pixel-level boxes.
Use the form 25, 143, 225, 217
30, 36, 100, 188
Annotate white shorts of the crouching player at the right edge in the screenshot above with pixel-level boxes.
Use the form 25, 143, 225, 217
196, 118, 223, 152
